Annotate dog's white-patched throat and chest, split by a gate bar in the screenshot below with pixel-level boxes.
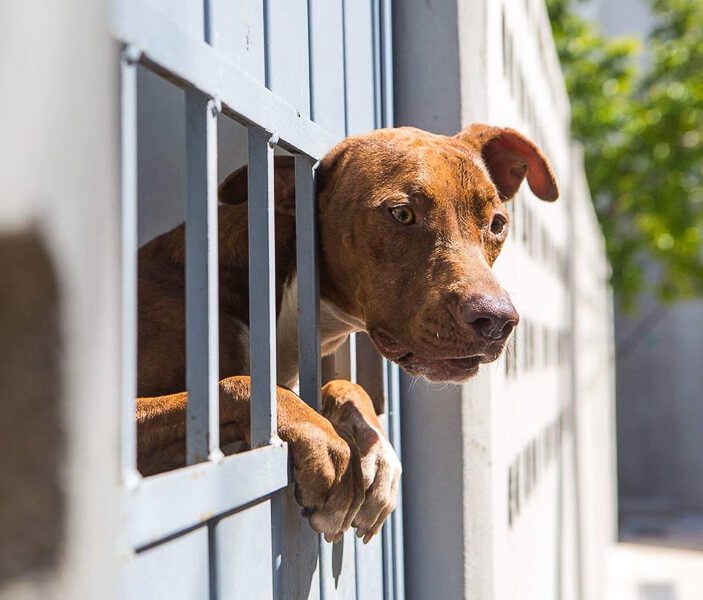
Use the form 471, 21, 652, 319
276, 276, 364, 387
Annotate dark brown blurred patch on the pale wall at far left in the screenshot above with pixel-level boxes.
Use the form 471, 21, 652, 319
0, 227, 65, 587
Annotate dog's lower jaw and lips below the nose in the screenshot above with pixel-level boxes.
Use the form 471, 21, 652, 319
369, 330, 497, 383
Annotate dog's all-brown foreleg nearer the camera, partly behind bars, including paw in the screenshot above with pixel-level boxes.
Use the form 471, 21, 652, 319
137, 377, 364, 541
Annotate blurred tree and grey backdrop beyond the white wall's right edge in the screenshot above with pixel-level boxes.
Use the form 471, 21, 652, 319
547, 0, 703, 598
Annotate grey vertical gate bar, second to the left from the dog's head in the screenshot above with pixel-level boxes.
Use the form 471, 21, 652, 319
248, 127, 276, 447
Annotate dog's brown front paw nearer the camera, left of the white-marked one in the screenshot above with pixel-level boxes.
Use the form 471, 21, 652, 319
285, 414, 364, 542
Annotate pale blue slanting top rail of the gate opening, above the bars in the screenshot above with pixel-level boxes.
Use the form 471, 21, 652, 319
111, 0, 338, 159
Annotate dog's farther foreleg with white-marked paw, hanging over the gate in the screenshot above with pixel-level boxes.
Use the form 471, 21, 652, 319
322, 380, 402, 543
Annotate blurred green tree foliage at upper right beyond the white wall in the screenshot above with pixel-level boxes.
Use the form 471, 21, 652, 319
547, 0, 703, 308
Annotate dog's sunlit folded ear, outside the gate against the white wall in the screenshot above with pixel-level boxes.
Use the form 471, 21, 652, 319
456, 123, 559, 202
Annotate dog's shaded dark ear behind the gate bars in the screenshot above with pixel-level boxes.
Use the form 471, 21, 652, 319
218, 156, 295, 216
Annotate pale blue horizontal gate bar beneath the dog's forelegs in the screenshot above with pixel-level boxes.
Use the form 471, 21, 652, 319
124, 444, 289, 548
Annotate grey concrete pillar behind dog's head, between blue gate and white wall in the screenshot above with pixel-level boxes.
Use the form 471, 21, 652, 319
393, 0, 492, 599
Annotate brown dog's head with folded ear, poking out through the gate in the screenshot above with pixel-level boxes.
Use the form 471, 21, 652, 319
318, 125, 558, 381
